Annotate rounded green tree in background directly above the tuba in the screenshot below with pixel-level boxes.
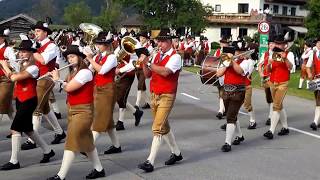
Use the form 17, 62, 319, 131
63, 1, 92, 27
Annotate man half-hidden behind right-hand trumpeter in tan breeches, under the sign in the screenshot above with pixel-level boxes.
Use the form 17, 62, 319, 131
258, 38, 276, 126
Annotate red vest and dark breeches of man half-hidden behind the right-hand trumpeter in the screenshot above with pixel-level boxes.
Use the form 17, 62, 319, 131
262, 51, 273, 104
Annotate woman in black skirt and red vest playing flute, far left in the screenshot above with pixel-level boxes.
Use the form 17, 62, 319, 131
0, 40, 55, 170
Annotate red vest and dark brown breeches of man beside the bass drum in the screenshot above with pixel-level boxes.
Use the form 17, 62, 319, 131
222, 59, 246, 124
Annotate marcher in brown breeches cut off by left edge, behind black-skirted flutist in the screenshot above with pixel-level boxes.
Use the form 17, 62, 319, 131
0, 28, 18, 122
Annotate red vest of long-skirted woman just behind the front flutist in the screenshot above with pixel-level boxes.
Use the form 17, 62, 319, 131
94, 55, 116, 86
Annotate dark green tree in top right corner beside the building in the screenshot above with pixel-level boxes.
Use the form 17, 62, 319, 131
305, 0, 320, 38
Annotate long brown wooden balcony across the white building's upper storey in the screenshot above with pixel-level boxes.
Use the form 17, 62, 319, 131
207, 13, 304, 26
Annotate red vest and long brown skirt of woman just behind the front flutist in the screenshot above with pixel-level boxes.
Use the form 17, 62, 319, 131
92, 55, 116, 132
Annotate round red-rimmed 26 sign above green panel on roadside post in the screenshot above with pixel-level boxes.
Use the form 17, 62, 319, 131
258, 21, 270, 58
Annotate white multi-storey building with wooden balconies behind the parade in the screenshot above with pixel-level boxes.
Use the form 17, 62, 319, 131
201, 0, 308, 41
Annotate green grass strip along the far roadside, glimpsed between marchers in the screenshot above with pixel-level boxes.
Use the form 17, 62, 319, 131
183, 67, 314, 100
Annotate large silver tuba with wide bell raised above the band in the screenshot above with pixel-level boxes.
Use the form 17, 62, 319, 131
79, 23, 103, 52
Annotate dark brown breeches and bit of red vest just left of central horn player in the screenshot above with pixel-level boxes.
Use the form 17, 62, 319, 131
116, 55, 135, 108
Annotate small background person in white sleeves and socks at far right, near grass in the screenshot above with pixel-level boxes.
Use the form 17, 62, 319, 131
298, 41, 312, 89
